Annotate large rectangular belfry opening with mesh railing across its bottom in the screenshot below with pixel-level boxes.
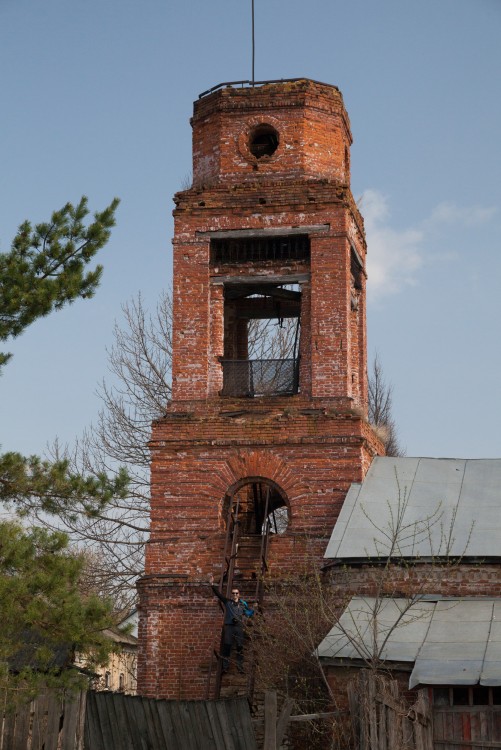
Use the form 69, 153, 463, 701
221, 283, 301, 398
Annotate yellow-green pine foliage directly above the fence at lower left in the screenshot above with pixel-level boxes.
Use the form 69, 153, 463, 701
0, 521, 111, 702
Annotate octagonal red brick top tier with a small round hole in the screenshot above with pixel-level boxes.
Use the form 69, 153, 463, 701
192, 79, 352, 187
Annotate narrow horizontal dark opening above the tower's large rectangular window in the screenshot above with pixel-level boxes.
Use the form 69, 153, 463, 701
210, 234, 310, 266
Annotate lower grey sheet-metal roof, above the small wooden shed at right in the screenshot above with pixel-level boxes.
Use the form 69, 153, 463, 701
318, 597, 501, 688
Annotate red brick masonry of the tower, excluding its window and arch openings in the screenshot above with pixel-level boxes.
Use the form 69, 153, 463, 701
139, 81, 383, 698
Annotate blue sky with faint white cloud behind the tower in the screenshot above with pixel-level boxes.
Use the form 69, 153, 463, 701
0, 0, 501, 458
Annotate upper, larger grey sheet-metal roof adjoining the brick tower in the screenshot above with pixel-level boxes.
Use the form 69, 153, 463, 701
325, 457, 501, 559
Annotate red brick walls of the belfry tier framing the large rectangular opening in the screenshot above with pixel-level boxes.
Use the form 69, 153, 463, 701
173, 191, 367, 409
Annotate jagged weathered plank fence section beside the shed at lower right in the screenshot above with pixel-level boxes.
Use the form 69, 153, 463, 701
348, 671, 433, 750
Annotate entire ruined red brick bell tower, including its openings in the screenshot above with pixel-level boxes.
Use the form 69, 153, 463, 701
139, 79, 383, 699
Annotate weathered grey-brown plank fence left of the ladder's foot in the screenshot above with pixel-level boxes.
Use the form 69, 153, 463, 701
0, 691, 257, 750
